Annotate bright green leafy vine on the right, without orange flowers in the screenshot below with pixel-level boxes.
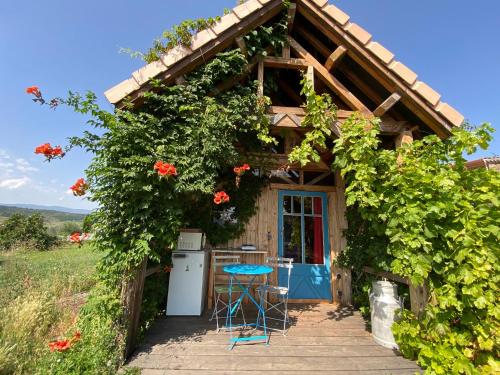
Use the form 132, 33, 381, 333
334, 115, 500, 374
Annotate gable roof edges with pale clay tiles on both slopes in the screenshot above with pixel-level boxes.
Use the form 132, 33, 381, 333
105, 0, 464, 135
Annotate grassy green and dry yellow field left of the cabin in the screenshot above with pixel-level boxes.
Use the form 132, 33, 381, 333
0, 245, 100, 374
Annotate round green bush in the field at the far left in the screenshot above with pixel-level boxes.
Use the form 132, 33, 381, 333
0, 214, 57, 250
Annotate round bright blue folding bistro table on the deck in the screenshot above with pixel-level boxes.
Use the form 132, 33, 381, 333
223, 264, 273, 350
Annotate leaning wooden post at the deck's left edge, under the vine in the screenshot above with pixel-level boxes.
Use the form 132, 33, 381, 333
121, 258, 148, 358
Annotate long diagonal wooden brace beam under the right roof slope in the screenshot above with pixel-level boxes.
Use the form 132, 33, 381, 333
289, 37, 372, 117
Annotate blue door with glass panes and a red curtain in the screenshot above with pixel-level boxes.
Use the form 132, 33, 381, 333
278, 190, 332, 301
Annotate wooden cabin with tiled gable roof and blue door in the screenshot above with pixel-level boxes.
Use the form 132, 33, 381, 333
105, 0, 463, 304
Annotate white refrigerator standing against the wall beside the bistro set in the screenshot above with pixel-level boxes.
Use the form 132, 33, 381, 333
167, 250, 208, 315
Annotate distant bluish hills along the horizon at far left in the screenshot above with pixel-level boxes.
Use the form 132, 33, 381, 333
0, 204, 90, 222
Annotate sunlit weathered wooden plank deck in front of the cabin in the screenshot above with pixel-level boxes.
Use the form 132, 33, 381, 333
128, 304, 420, 375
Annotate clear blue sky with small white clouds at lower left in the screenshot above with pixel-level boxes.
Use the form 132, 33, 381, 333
0, 0, 500, 208
